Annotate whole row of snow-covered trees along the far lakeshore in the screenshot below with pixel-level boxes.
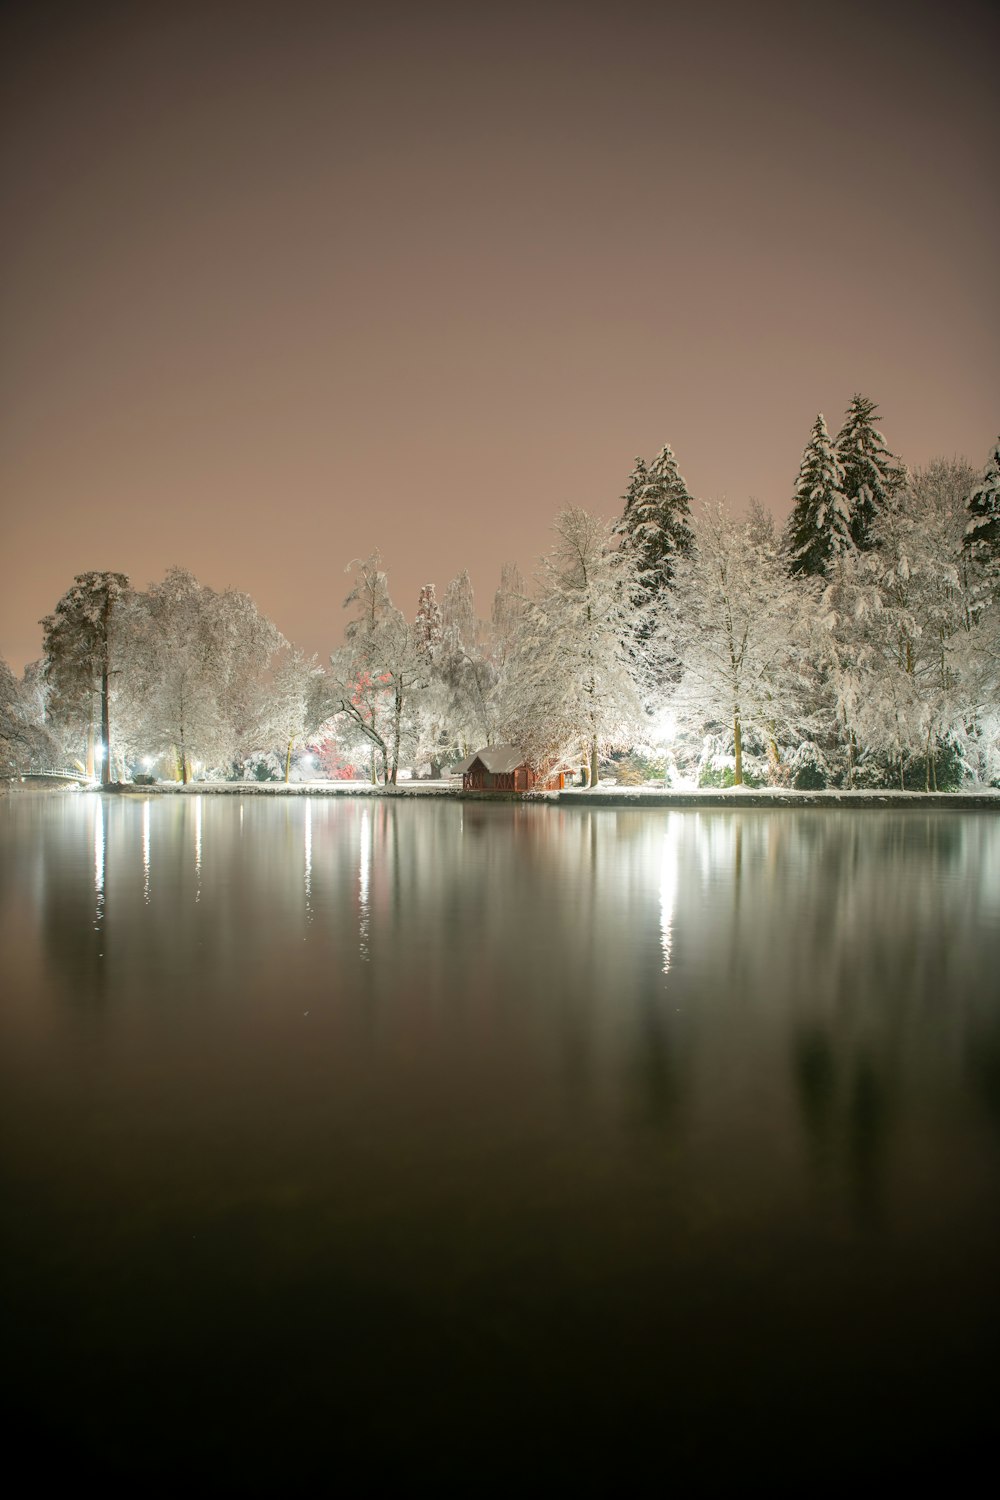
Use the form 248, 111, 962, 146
0, 396, 1000, 789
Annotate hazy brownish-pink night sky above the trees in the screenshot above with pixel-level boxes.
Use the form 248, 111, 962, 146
0, 0, 1000, 671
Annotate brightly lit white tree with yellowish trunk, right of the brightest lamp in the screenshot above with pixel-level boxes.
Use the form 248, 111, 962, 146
664, 503, 819, 786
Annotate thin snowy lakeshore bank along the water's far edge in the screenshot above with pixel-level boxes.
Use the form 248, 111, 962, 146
7, 782, 1000, 812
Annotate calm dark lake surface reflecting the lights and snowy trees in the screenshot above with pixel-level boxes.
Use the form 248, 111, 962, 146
0, 794, 1000, 1493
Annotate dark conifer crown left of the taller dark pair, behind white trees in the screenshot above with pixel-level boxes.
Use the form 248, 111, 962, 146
615, 443, 694, 614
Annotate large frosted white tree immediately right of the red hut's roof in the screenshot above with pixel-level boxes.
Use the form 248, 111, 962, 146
502, 507, 642, 785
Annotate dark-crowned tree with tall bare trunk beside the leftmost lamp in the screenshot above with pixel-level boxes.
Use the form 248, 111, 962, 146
42, 573, 130, 786
